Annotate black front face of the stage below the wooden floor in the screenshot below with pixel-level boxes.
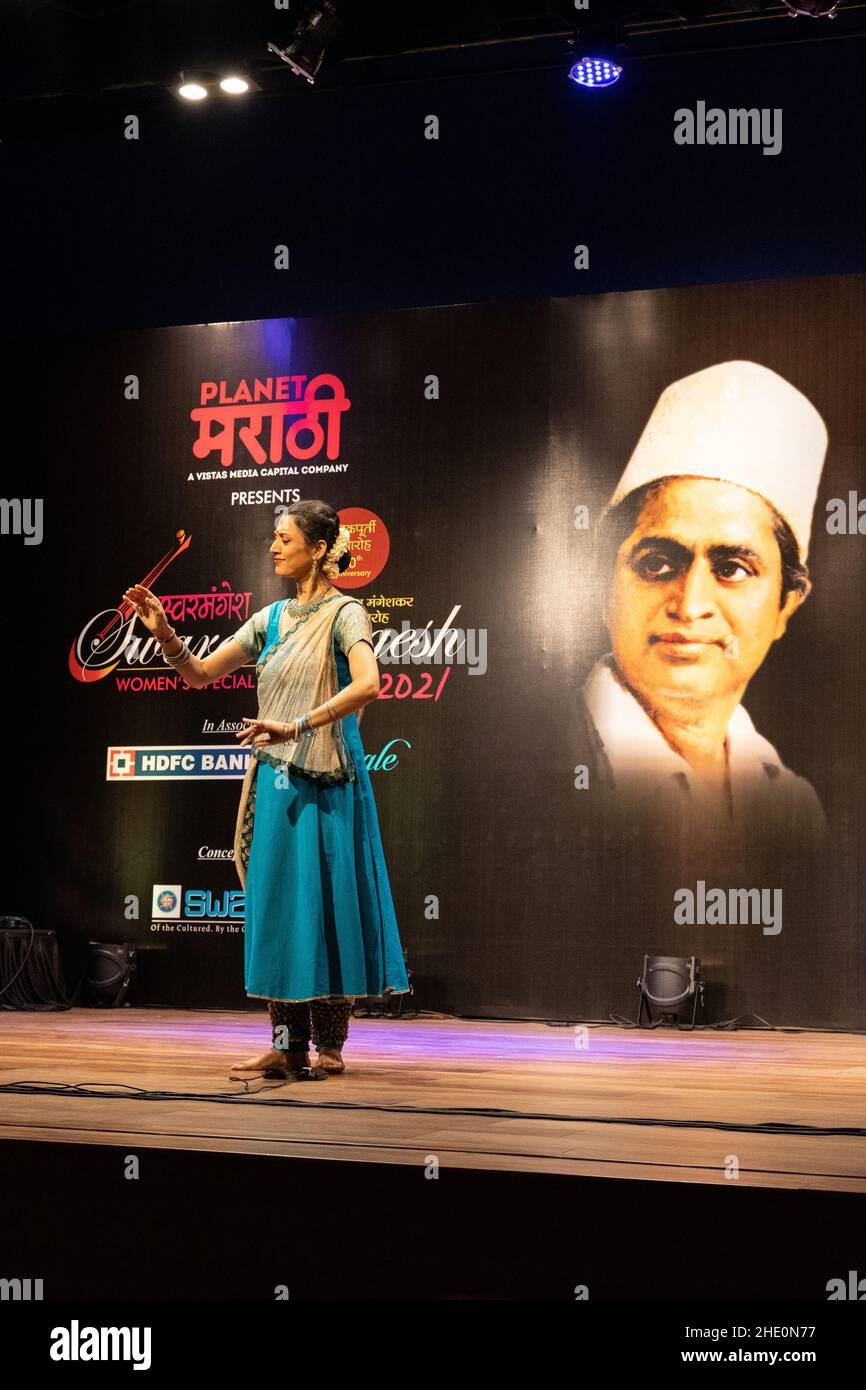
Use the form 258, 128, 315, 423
0, 1140, 866, 1301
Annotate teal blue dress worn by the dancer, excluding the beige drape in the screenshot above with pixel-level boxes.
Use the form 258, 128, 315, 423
235, 602, 409, 1001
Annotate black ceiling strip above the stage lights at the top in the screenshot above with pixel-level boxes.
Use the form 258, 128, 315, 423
0, 0, 866, 103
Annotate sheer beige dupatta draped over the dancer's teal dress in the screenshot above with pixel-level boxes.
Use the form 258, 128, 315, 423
235, 594, 354, 887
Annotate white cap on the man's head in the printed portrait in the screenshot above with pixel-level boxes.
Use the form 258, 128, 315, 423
607, 361, 827, 560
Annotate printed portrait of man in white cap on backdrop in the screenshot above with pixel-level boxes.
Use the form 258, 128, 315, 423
578, 361, 828, 847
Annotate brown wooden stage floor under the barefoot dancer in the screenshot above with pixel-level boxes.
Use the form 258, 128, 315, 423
0, 1009, 866, 1193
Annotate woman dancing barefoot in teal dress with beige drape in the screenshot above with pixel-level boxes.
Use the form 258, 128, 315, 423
125, 500, 409, 1074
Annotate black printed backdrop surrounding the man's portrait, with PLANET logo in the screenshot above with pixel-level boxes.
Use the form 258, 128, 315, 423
45, 277, 866, 1026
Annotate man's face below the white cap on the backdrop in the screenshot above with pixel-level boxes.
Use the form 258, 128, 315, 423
605, 478, 799, 705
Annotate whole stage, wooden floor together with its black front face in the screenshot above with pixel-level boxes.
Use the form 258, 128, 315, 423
0, 1008, 866, 1300
